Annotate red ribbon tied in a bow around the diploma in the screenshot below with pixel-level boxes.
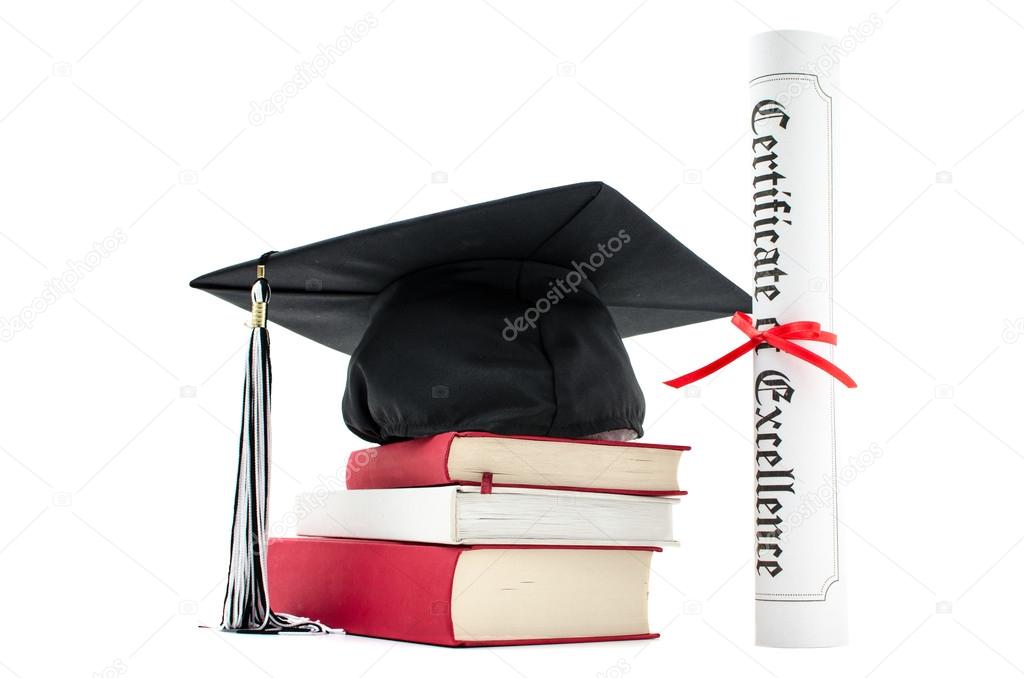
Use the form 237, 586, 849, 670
665, 310, 857, 388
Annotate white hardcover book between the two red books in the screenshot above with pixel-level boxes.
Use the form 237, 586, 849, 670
296, 485, 679, 546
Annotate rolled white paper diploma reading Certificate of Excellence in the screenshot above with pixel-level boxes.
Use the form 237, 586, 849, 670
751, 31, 847, 647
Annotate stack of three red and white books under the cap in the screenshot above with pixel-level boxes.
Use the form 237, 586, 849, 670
268, 432, 687, 645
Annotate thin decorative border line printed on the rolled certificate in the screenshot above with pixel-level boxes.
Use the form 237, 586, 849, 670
750, 72, 840, 602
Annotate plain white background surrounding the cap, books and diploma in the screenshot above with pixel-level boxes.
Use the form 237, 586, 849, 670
0, 0, 1024, 678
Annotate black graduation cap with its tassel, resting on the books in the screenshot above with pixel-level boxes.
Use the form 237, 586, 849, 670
191, 182, 751, 629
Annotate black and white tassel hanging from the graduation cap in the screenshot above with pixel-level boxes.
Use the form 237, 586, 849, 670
220, 261, 329, 633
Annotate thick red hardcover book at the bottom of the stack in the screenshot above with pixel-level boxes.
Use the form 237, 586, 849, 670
267, 537, 660, 646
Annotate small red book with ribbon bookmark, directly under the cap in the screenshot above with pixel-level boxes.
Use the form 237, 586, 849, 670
345, 432, 689, 496
